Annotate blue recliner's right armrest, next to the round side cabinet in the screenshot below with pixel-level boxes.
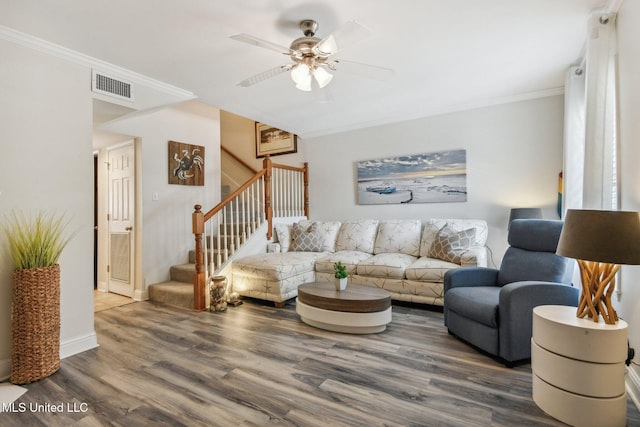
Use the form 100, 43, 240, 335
499, 281, 579, 361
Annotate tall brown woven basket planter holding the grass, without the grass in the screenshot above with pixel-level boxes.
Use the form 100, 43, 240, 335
11, 264, 60, 384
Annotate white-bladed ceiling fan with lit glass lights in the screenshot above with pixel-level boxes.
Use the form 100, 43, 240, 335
231, 19, 393, 92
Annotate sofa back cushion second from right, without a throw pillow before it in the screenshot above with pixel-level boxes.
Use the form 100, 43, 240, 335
373, 219, 422, 256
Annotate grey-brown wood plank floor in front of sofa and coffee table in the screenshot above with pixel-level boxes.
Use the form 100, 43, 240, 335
0, 301, 640, 427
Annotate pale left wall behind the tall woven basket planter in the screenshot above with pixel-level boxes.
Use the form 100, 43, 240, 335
0, 40, 95, 378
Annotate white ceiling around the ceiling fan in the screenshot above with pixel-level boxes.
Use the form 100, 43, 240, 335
0, 0, 608, 138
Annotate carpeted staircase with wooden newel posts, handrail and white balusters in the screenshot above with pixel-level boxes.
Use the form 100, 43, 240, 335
148, 156, 309, 311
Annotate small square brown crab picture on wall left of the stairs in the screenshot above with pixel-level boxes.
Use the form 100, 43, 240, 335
168, 141, 204, 185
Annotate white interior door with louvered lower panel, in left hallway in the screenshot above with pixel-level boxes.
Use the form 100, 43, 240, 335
107, 143, 135, 297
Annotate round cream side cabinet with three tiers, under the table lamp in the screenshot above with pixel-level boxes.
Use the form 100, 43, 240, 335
531, 305, 627, 427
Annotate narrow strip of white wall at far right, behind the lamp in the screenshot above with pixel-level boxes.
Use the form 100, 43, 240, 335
616, 1, 640, 401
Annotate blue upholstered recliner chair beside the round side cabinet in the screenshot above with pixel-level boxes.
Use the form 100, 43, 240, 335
444, 219, 579, 367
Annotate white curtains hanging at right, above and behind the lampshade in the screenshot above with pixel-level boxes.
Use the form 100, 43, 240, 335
563, 12, 618, 216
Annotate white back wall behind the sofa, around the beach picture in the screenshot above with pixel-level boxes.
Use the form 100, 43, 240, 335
304, 96, 564, 264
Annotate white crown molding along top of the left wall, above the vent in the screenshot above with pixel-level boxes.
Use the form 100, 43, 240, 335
0, 25, 196, 100
